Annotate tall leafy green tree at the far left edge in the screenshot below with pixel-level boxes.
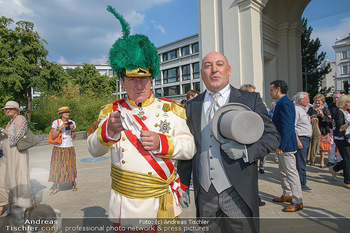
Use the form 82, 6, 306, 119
0, 16, 63, 121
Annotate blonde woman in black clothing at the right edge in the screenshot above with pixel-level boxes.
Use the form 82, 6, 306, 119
329, 95, 350, 189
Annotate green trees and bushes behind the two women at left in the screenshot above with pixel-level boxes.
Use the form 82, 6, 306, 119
0, 16, 117, 133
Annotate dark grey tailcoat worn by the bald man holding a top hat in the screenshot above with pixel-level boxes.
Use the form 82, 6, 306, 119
178, 86, 279, 217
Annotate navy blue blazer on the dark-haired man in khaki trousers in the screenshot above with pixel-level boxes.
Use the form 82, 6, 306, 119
272, 95, 298, 152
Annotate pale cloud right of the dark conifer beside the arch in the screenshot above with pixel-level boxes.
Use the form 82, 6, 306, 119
311, 17, 350, 61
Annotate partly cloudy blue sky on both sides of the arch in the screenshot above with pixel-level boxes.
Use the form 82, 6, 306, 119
0, 0, 350, 64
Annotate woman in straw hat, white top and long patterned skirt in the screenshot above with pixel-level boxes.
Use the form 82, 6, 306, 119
49, 106, 78, 195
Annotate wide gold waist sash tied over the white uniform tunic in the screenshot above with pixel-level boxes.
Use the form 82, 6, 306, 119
111, 164, 175, 218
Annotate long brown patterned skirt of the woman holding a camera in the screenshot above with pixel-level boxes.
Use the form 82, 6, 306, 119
49, 146, 77, 184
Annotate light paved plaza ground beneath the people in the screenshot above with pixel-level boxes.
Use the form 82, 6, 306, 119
0, 140, 350, 233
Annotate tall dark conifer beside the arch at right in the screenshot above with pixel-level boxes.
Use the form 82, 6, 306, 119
301, 18, 331, 99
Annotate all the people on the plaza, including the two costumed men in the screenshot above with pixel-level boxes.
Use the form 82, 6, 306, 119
0, 7, 350, 232
